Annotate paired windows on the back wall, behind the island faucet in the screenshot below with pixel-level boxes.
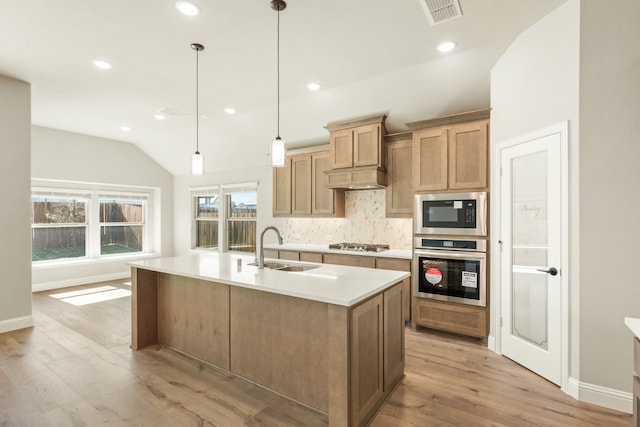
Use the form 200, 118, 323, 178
191, 183, 258, 252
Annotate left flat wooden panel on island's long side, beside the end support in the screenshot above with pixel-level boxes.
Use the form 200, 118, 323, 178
157, 273, 229, 369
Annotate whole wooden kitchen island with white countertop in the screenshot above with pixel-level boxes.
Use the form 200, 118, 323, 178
131, 253, 409, 426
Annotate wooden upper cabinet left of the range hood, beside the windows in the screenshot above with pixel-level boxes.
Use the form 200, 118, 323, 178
273, 145, 344, 217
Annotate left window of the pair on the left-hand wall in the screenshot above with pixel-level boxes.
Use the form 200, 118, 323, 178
31, 196, 88, 261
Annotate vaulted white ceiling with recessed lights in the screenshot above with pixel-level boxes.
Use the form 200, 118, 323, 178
0, 0, 565, 175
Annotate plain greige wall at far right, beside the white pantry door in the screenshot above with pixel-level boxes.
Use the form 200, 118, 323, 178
579, 0, 640, 398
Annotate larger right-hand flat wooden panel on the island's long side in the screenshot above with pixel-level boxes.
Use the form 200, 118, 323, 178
230, 286, 329, 413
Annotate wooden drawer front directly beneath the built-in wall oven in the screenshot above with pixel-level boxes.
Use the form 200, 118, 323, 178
411, 297, 487, 338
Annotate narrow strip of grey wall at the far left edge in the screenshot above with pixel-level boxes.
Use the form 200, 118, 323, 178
0, 76, 33, 333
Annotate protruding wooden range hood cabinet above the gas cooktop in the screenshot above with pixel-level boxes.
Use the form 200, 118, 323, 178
325, 115, 386, 189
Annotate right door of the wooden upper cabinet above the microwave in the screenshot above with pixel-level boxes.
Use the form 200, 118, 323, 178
449, 120, 489, 190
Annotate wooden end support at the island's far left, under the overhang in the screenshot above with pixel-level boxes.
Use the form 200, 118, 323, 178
131, 267, 158, 350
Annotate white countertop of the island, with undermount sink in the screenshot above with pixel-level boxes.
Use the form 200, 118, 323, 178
128, 253, 409, 307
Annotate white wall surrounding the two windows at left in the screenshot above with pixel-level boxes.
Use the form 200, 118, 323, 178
31, 126, 173, 290
